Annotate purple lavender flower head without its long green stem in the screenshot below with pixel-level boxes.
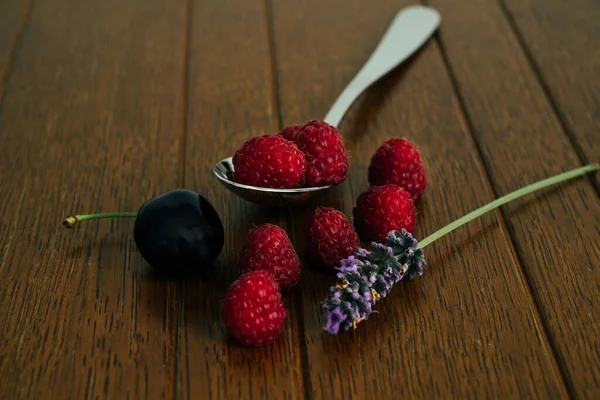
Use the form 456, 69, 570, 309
323, 229, 425, 335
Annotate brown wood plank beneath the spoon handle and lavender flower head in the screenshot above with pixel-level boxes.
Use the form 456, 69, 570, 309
272, 0, 566, 398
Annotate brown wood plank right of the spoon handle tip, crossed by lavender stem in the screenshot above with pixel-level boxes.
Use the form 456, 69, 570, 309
431, 0, 600, 398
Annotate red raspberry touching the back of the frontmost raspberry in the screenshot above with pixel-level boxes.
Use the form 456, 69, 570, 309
240, 224, 301, 292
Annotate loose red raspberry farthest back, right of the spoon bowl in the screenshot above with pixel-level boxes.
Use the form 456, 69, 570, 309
369, 138, 427, 201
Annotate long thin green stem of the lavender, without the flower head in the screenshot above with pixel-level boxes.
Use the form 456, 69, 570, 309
418, 163, 600, 249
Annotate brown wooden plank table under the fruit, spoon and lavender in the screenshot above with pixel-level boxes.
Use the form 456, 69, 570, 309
0, 0, 600, 399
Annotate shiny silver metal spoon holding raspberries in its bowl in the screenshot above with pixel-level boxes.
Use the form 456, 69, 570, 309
213, 6, 441, 205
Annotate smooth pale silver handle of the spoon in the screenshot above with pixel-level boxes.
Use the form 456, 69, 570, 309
324, 6, 441, 127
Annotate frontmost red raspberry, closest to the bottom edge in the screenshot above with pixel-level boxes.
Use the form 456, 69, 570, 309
221, 271, 287, 346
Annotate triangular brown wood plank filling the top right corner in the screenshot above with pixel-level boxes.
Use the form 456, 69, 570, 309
504, 0, 600, 190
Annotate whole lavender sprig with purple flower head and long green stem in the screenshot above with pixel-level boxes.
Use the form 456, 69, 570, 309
323, 163, 600, 335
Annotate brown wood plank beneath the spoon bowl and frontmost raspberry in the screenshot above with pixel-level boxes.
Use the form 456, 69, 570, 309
177, 0, 303, 399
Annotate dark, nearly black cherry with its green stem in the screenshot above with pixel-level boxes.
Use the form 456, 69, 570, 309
63, 189, 224, 275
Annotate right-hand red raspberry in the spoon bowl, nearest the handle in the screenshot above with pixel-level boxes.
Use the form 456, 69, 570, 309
279, 120, 348, 187
